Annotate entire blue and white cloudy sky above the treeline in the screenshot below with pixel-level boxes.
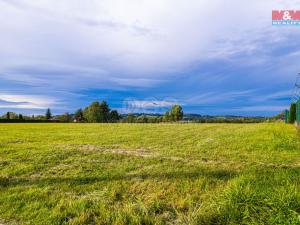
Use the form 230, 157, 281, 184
0, 0, 300, 116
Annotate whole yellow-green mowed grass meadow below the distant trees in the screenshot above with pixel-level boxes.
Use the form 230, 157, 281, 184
0, 123, 300, 225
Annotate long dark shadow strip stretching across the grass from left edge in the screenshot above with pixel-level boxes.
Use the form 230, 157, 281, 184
0, 169, 237, 187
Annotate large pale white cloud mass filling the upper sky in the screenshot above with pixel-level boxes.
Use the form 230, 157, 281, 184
0, 0, 297, 78
